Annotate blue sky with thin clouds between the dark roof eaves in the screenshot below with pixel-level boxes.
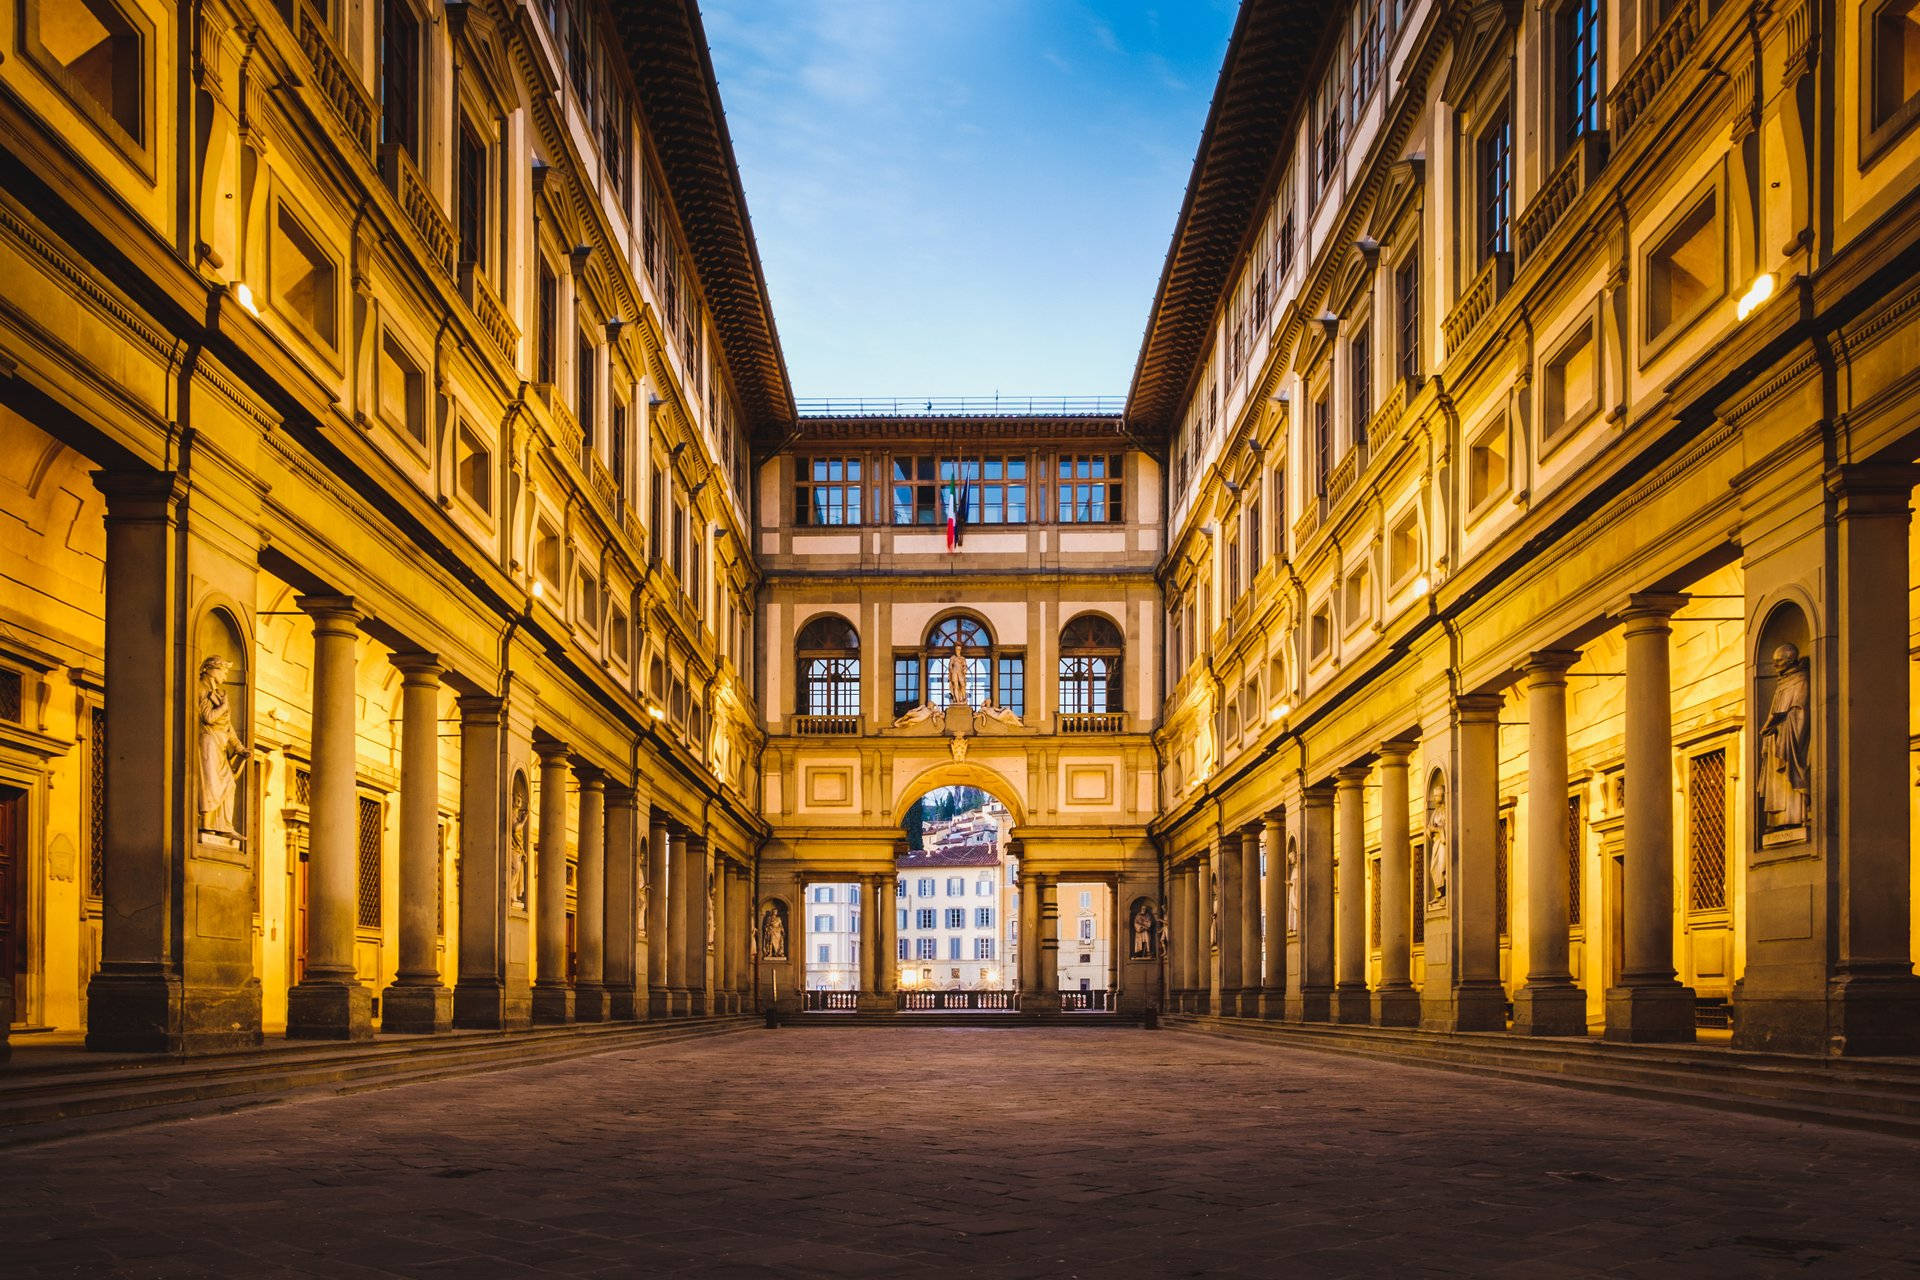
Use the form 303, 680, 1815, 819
701, 0, 1235, 397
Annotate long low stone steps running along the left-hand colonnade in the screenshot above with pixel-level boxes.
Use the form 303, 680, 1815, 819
0, 1015, 758, 1148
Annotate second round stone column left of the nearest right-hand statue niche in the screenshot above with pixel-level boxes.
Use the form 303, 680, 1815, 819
1513, 649, 1586, 1036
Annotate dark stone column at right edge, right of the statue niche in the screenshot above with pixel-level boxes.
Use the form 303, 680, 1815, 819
1812, 466, 1920, 1055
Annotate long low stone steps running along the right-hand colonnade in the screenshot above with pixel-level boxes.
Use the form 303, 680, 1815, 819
1164, 1015, 1920, 1138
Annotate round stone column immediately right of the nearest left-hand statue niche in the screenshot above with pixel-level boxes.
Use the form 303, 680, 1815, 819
286, 595, 372, 1040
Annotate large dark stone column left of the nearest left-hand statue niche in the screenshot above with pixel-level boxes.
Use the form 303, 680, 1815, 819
84, 470, 187, 1061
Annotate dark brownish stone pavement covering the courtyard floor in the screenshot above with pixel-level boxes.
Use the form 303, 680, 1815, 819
0, 1027, 1920, 1278
